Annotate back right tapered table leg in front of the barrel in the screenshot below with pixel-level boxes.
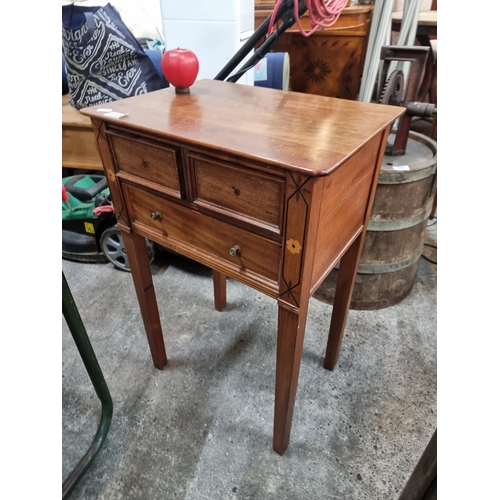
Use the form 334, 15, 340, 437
324, 232, 364, 370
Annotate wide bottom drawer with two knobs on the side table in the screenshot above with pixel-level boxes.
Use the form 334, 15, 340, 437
123, 184, 281, 284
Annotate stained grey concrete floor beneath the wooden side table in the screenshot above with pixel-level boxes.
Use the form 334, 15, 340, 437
62, 216, 437, 500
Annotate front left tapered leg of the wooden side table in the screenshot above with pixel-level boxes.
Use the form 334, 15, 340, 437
122, 231, 167, 369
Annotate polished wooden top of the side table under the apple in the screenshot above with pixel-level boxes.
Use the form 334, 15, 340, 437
81, 80, 404, 176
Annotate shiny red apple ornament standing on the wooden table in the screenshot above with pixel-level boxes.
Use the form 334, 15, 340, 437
161, 47, 199, 93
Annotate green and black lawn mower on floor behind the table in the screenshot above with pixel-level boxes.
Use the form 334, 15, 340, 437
62, 174, 155, 271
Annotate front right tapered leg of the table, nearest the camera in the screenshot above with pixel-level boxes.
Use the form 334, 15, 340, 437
273, 305, 307, 455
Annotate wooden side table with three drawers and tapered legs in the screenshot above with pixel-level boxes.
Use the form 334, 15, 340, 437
81, 80, 404, 454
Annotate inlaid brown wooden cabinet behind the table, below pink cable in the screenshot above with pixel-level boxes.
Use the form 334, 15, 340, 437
255, 2, 373, 99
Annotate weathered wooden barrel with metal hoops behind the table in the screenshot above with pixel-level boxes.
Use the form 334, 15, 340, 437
315, 132, 437, 310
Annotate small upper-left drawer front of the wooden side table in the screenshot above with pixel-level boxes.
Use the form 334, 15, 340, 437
110, 134, 180, 195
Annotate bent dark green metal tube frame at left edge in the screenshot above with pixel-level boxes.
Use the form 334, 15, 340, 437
62, 273, 113, 500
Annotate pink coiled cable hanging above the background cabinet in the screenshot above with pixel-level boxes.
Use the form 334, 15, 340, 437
267, 0, 348, 36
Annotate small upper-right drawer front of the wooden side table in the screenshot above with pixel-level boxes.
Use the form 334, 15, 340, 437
187, 153, 285, 234
